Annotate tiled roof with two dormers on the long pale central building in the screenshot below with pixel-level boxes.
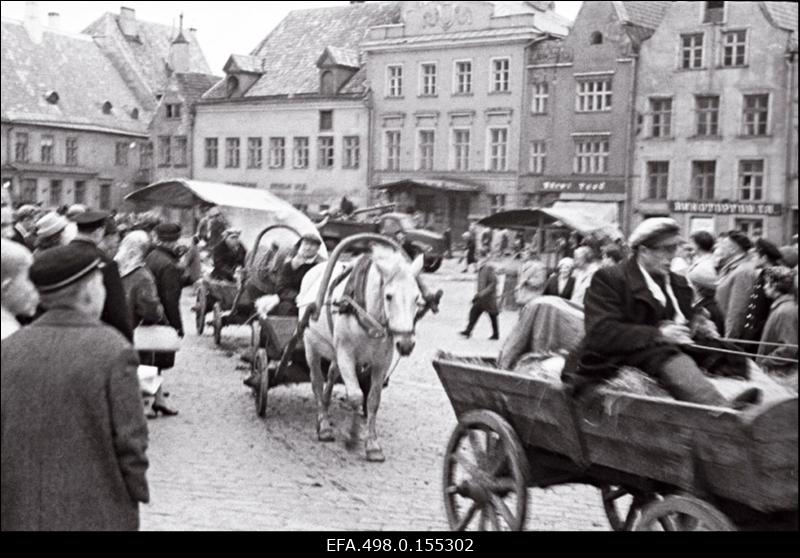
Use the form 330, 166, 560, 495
246, 2, 400, 97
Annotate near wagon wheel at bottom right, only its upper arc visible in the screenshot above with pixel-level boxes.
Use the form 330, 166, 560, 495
633, 496, 736, 531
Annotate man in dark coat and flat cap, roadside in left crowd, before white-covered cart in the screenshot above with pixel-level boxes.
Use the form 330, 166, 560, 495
145, 223, 183, 342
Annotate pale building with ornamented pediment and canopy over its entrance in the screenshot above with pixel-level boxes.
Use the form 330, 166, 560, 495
362, 2, 568, 235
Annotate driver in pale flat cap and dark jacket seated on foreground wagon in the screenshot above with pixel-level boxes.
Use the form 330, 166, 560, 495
563, 218, 760, 412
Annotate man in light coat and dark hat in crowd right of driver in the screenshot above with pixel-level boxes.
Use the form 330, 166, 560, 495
714, 231, 758, 339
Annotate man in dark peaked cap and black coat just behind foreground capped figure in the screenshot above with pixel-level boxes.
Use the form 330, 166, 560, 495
70, 211, 133, 341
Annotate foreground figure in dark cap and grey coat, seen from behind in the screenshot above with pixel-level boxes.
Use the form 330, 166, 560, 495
0, 244, 149, 531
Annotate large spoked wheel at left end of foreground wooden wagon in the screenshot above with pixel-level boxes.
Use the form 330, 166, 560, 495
443, 411, 528, 531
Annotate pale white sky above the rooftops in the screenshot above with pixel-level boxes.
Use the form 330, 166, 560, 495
0, 0, 582, 75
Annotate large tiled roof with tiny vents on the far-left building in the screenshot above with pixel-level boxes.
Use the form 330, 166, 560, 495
2, 19, 149, 133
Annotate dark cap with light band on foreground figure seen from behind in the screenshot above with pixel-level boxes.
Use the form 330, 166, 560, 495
30, 244, 104, 293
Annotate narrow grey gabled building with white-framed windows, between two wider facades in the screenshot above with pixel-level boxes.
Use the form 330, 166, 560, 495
519, 1, 670, 234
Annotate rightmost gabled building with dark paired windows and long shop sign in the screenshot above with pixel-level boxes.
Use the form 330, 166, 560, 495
631, 2, 797, 242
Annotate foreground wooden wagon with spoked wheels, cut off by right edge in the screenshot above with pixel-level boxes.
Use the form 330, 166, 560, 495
433, 353, 798, 530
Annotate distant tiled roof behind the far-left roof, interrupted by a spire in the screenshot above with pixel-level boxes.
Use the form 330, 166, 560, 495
83, 13, 211, 95
